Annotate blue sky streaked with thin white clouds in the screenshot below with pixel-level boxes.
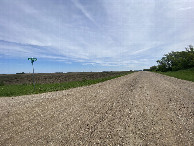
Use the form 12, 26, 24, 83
0, 0, 194, 73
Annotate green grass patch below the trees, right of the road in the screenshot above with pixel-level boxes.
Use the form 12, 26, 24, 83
157, 68, 194, 82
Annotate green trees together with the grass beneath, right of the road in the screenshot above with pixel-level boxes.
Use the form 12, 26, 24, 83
144, 45, 194, 81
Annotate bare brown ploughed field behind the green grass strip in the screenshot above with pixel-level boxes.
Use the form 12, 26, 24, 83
0, 71, 129, 85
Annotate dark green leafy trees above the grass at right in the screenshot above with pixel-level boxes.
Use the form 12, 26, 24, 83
144, 45, 194, 72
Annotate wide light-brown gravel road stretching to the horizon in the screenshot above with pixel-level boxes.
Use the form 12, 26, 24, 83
0, 72, 194, 146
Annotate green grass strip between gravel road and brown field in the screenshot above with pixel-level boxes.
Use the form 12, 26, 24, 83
0, 73, 133, 97
